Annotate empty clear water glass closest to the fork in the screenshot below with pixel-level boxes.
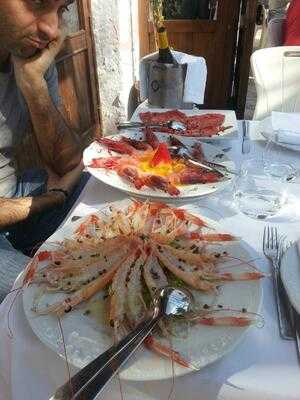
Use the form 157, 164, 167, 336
234, 159, 290, 220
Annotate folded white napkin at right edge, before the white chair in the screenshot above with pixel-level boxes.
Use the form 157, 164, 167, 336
272, 111, 300, 145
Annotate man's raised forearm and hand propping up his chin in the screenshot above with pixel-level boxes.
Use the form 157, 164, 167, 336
12, 34, 82, 175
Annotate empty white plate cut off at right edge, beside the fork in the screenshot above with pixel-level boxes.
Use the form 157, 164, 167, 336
280, 242, 300, 314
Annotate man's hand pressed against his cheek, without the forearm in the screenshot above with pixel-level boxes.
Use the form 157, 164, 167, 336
12, 26, 66, 90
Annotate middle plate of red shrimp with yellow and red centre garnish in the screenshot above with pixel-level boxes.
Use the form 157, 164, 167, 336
83, 129, 235, 200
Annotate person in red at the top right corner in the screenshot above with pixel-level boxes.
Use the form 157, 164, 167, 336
283, 0, 300, 46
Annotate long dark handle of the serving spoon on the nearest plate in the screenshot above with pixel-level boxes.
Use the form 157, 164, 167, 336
50, 310, 162, 400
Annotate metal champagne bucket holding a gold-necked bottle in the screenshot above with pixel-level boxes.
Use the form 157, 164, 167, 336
148, 61, 193, 109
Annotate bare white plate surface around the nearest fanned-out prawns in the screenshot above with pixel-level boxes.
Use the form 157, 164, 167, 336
23, 203, 262, 381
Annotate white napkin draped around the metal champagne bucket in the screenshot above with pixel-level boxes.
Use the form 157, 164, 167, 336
140, 51, 207, 104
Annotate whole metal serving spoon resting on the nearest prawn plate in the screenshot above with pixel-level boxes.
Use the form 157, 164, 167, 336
49, 286, 193, 400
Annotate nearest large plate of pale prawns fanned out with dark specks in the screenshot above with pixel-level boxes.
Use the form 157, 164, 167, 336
23, 200, 265, 381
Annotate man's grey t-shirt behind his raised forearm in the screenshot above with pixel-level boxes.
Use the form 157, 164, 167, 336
0, 65, 60, 197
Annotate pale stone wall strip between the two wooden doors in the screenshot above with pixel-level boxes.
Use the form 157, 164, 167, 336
91, 0, 137, 135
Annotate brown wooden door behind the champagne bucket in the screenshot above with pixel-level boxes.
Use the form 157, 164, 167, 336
139, 0, 240, 109
